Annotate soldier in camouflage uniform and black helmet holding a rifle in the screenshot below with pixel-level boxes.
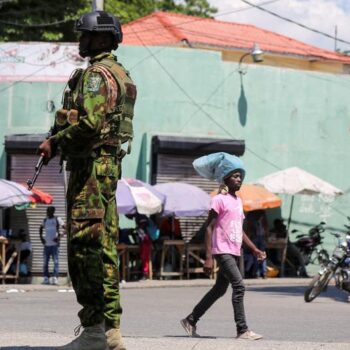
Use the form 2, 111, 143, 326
39, 11, 136, 350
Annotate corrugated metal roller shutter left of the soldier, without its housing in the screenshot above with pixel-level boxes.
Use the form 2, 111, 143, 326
8, 153, 67, 275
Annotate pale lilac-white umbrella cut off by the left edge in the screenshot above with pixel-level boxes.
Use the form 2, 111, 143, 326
0, 179, 32, 208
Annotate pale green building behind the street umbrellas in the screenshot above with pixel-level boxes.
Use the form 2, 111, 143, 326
0, 14, 350, 273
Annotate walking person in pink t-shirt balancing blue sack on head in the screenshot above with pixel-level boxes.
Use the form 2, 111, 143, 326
181, 152, 265, 340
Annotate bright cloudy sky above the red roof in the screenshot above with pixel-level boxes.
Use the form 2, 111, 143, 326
208, 0, 350, 51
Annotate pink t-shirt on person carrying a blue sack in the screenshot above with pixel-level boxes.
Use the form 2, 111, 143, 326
211, 194, 244, 256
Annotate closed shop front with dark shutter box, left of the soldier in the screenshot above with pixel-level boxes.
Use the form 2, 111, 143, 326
5, 135, 67, 276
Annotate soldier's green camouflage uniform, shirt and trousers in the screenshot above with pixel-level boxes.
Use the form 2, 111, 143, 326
55, 53, 136, 328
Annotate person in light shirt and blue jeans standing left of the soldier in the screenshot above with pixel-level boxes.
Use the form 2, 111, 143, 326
39, 206, 64, 285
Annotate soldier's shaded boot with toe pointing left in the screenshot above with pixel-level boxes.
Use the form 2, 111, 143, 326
56, 321, 107, 350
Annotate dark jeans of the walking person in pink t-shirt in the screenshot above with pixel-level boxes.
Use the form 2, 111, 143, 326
188, 254, 248, 334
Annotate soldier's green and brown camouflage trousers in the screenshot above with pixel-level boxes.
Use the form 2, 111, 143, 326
67, 156, 122, 328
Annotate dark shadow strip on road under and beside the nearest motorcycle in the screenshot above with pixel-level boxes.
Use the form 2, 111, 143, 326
247, 285, 349, 303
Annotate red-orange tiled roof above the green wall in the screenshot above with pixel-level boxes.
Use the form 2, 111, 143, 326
123, 12, 350, 63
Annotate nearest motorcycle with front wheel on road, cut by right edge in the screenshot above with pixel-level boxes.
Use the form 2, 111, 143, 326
304, 233, 350, 303
